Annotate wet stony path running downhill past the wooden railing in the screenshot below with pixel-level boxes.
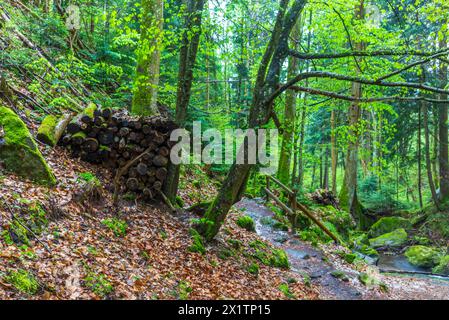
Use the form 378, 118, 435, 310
236, 199, 449, 300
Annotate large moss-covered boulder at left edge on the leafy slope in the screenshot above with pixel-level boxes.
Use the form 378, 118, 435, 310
0, 106, 56, 185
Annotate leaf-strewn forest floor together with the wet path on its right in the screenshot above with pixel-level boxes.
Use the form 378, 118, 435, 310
0, 131, 449, 299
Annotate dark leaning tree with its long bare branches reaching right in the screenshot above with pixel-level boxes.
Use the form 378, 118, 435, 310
197, 0, 449, 240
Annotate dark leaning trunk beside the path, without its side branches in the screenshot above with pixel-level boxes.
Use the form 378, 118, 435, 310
198, 0, 306, 240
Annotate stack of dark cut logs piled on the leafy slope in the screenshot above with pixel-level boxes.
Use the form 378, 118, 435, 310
40, 106, 176, 199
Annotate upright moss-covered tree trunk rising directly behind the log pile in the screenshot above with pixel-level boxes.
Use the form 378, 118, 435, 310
131, 0, 164, 116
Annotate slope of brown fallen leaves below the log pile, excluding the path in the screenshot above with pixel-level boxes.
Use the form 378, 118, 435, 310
0, 148, 319, 299
